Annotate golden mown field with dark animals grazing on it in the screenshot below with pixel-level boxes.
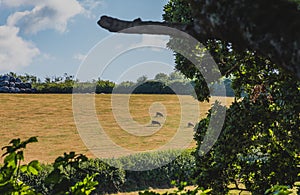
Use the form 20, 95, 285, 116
0, 94, 232, 163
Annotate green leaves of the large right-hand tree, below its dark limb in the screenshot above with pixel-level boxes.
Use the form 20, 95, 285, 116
164, 0, 300, 194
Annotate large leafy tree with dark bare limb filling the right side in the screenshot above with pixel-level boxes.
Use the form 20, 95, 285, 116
98, 0, 300, 194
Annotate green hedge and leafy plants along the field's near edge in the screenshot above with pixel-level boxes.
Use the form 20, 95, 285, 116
0, 137, 195, 194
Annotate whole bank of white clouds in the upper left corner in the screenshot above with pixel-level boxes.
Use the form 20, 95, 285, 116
0, 0, 103, 71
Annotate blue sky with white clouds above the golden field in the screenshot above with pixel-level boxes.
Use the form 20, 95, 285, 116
0, 0, 174, 82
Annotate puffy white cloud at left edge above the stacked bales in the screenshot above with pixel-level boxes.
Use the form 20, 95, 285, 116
0, 26, 40, 71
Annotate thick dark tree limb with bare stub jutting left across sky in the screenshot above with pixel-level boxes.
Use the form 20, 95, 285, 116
98, 0, 300, 78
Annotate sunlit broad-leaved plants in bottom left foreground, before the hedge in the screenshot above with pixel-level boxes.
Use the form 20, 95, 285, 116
0, 137, 98, 195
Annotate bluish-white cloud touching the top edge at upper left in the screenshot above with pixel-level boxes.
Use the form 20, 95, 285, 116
2, 0, 85, 33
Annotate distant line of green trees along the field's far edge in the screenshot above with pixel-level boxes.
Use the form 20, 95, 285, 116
0, 72, 234, 96
